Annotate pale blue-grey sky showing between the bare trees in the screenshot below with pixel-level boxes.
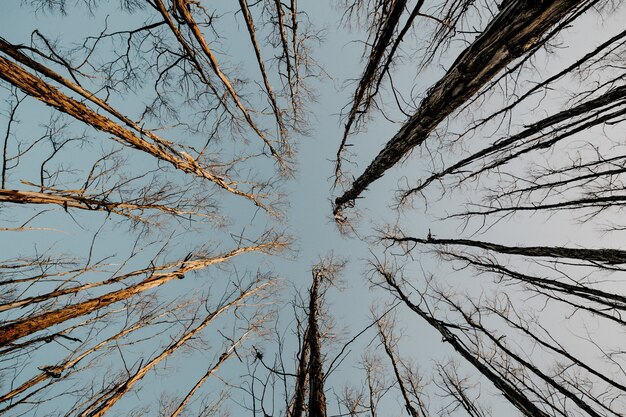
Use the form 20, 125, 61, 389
0, 0, 624, 415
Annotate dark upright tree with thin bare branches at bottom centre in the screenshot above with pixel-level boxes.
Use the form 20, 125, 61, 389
242, 256, 343, 417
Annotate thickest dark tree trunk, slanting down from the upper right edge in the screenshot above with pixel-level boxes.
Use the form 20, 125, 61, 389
334, 0, 586, 214
